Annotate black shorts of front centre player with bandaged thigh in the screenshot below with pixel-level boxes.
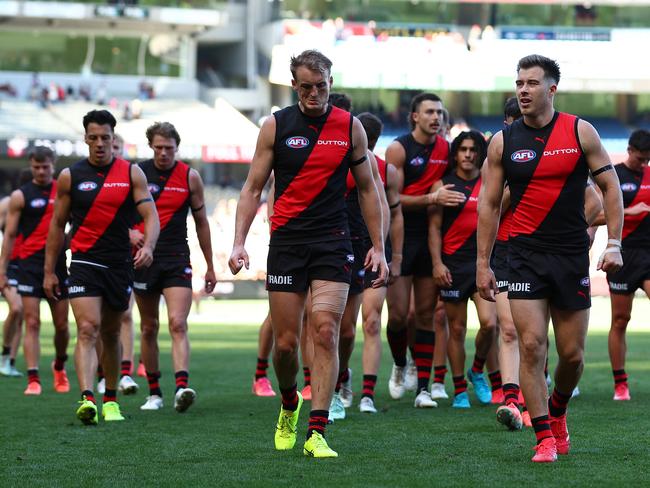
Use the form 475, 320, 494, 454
266, 240, 354, 293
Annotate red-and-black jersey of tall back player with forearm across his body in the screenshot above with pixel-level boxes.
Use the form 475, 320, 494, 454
395, 132, 449, 233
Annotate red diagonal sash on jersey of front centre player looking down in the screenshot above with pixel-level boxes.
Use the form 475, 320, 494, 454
271, 107, 352, 232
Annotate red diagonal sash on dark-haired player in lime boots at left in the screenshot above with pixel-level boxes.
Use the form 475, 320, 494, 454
70, 158, 131, 253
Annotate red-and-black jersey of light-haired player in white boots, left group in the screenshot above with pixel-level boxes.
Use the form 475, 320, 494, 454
136, 159, 190, 257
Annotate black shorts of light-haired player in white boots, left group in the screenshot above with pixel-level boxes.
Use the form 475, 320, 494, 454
133, 257, 192, 295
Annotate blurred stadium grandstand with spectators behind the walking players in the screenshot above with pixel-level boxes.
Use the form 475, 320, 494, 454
0, 0, 650, 292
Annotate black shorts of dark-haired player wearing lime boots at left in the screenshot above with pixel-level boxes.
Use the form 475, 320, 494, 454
68, 261, 133, 312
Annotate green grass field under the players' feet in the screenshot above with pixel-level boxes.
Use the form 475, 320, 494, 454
0, 298, 650, 487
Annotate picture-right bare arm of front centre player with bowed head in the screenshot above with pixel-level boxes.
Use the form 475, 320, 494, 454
350, 117, 388, 288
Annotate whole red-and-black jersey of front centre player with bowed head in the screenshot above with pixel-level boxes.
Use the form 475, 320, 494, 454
271, 105, 352, 245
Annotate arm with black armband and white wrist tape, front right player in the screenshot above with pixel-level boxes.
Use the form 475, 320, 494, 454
578, 120, 623, 272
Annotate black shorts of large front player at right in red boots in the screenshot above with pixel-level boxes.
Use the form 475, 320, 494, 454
508, 243, 591, 310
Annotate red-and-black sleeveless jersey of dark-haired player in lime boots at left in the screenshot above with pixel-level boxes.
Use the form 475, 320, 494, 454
70, 158, 135, 267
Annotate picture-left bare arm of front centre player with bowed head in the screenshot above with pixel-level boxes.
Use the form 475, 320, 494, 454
228, 116, 275, 274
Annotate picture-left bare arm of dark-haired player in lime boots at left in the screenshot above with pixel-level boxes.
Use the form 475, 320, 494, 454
43, 168, 72, 300
